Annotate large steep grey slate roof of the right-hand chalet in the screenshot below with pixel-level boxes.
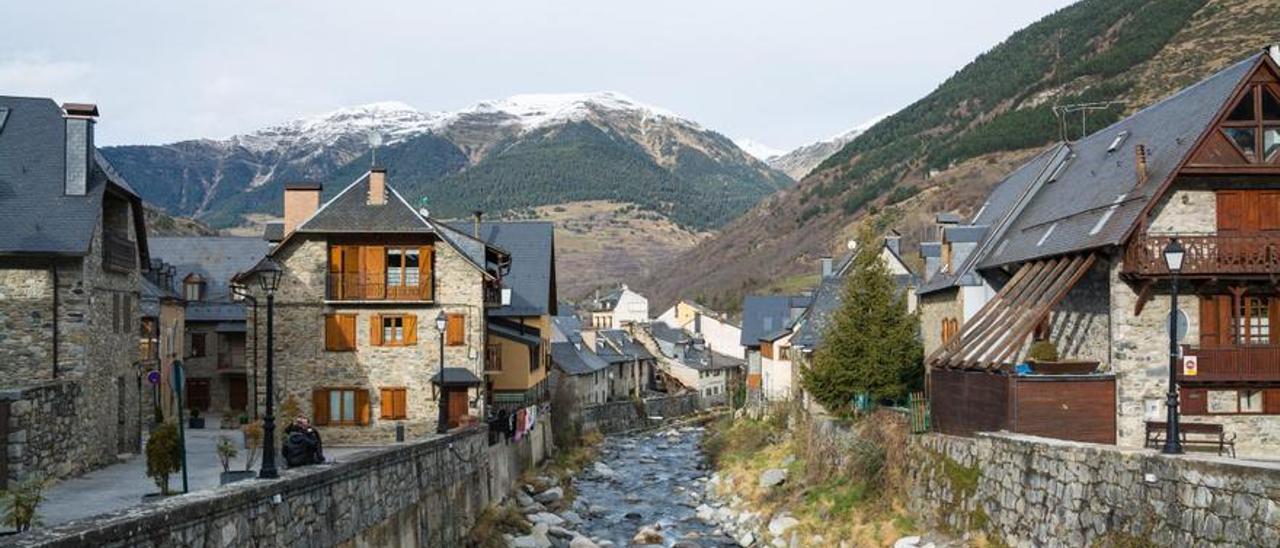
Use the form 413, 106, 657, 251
978, 54, 1266, 268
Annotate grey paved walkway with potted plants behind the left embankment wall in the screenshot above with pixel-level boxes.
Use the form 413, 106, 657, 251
38, 416, 369, 526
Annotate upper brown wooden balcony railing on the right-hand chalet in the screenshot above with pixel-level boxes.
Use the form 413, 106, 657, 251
1124, 233, 1280, 275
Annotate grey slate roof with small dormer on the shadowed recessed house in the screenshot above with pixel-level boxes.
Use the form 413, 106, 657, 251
151, 236, 270, 302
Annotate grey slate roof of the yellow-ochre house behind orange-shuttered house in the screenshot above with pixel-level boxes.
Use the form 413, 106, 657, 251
451, 222, 556, 316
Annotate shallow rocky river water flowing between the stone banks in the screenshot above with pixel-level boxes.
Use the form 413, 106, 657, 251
573, 426, 737, 548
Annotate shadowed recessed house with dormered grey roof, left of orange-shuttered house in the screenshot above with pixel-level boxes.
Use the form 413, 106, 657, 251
151, 237, 268, 425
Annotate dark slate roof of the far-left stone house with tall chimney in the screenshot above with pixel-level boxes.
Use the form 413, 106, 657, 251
0, 96, 150, 258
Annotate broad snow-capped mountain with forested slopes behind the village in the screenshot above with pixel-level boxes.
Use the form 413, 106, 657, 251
104, 91, 790, 229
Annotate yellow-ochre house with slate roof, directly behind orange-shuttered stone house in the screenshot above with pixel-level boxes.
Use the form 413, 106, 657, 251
453, 214, 557, 410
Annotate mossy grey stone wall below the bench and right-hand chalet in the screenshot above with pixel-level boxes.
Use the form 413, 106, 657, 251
909, 434, 1280, 547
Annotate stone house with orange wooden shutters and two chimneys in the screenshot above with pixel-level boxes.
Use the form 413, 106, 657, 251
237, 168, 509, 443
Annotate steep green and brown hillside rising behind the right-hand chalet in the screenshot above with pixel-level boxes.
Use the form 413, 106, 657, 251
646, 0, 1280, 305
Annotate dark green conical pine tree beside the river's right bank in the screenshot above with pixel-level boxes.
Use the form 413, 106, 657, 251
800, 233, 923, 411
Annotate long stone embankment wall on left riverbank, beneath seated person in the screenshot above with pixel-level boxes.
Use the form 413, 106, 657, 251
10, 426, 494, 547
